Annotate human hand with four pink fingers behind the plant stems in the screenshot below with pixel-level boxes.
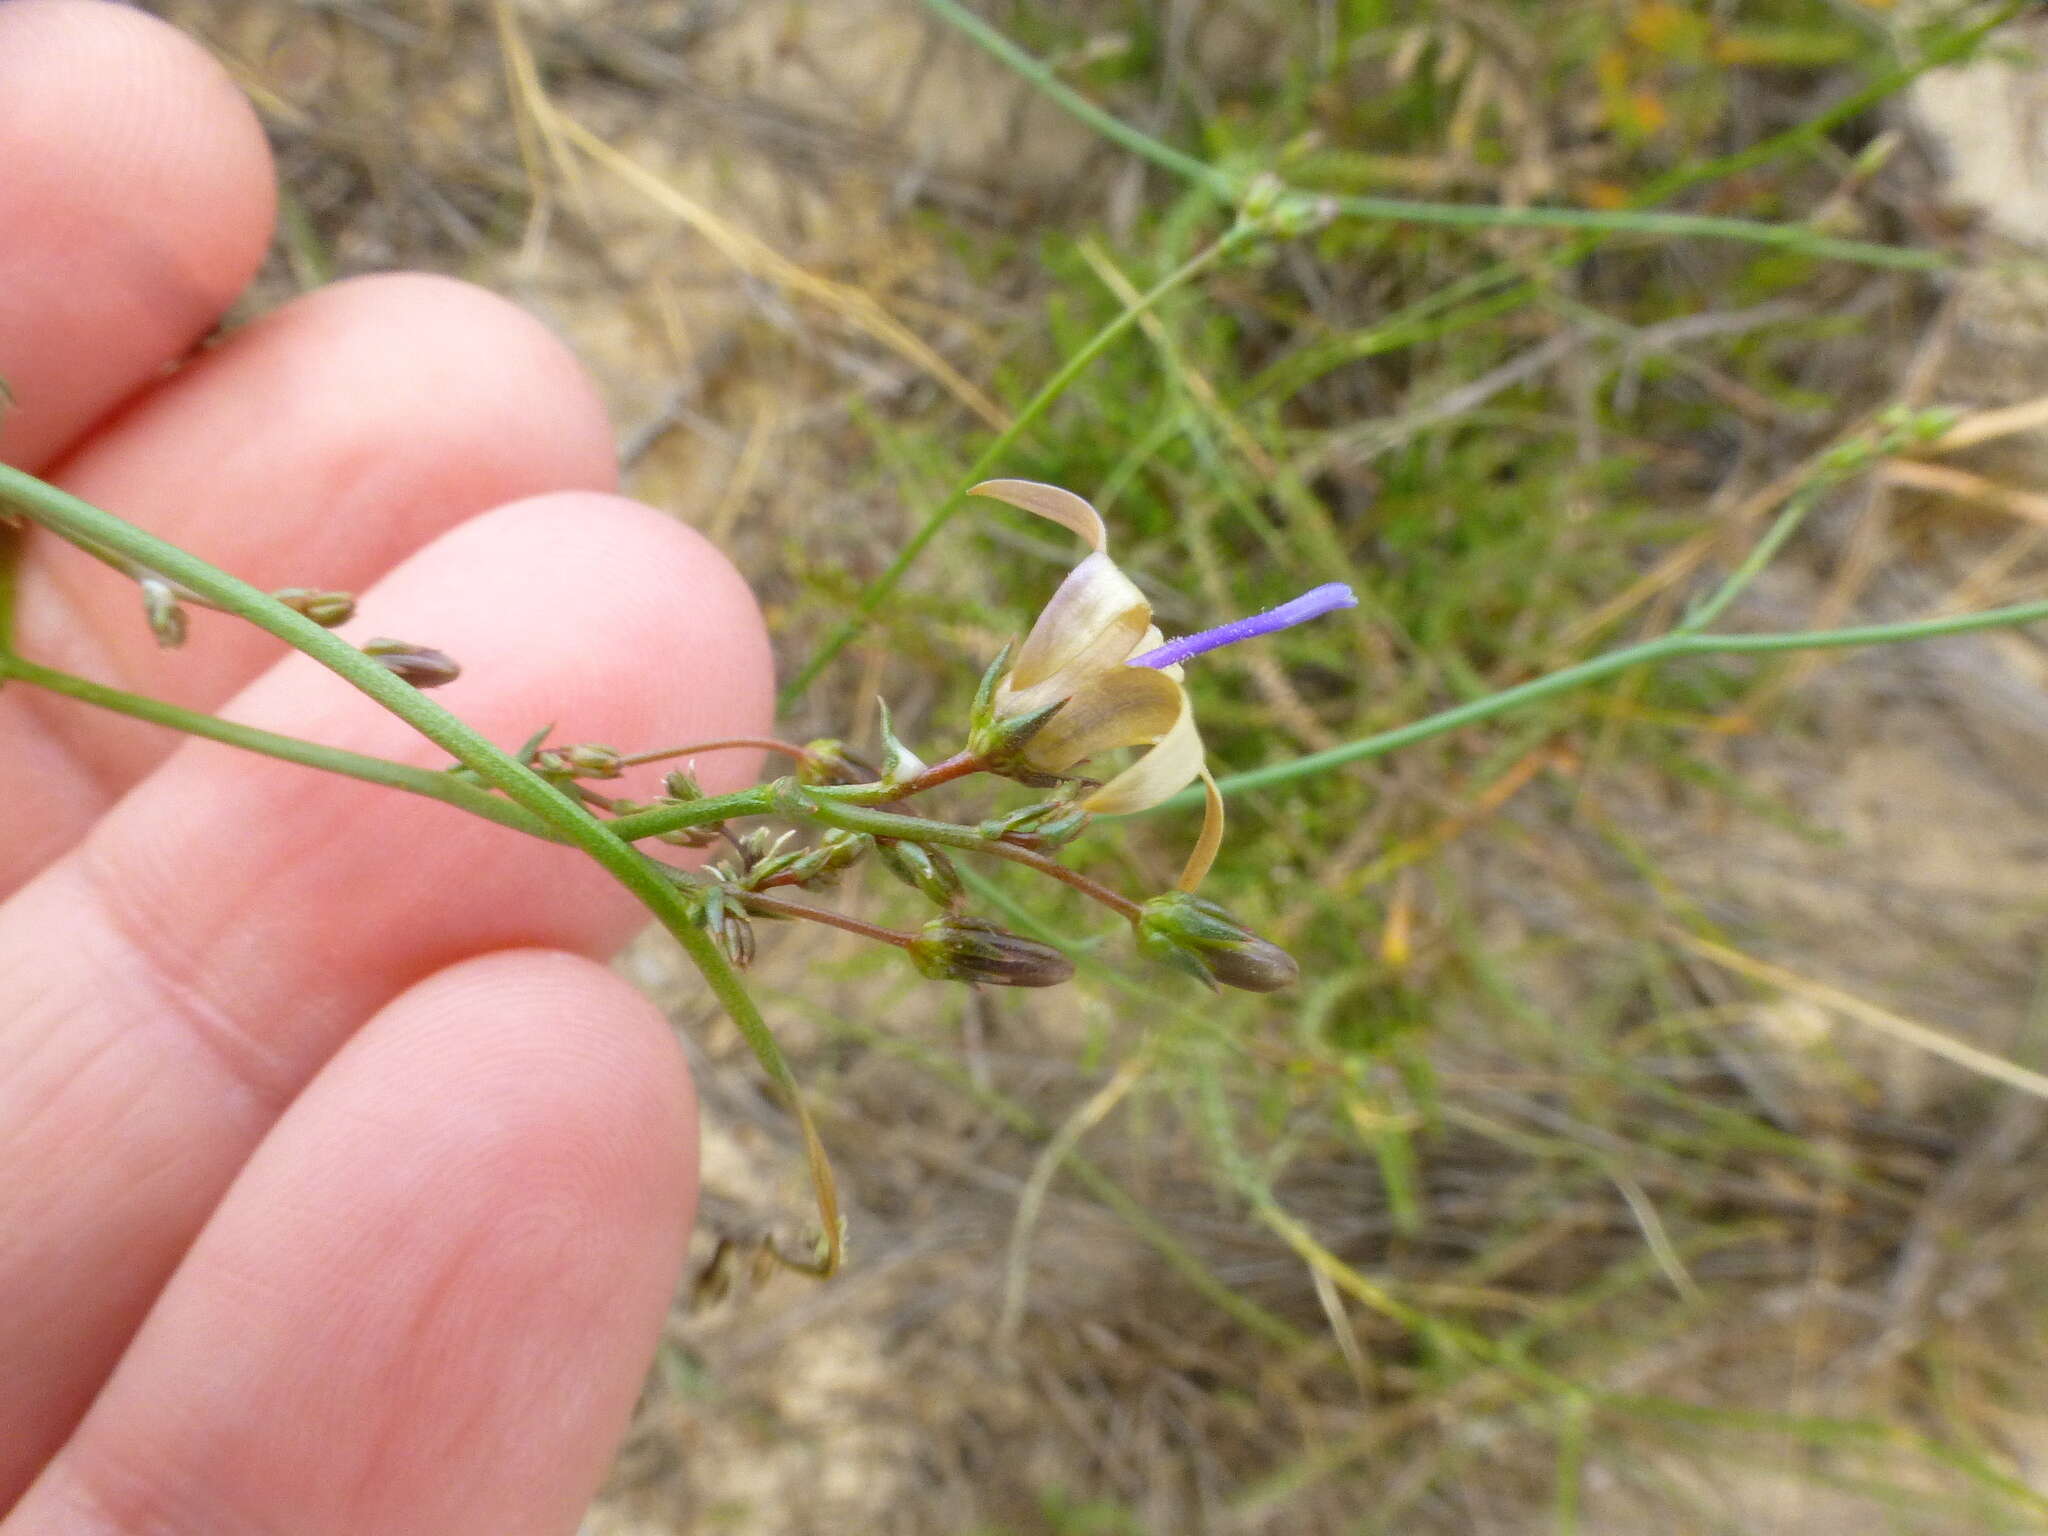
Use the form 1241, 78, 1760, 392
0, 0, 770, 1536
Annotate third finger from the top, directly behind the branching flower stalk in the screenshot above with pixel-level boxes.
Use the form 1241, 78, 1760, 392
0, 494, 772, 1507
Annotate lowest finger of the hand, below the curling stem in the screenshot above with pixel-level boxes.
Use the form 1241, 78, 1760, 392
0, 950, 696, 1536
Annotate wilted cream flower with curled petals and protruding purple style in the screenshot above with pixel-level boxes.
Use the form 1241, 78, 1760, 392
971, 479, 1358, 891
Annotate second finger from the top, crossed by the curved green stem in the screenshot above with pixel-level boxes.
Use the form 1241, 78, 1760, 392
0, 274, 614, 893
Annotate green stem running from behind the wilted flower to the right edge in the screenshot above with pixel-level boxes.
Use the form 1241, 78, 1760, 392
1196, 600, 2048, 809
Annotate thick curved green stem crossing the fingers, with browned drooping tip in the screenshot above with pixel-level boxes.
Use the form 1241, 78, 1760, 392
0, 465, 844, 1274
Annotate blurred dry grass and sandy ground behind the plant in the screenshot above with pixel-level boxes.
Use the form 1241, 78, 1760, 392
158, 0, 2048, 1536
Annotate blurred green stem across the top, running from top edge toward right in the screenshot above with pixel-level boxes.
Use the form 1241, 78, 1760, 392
924, 0, 1954, 272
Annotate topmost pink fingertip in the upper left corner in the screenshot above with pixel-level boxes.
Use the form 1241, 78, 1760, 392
0, 0, 276, 469
